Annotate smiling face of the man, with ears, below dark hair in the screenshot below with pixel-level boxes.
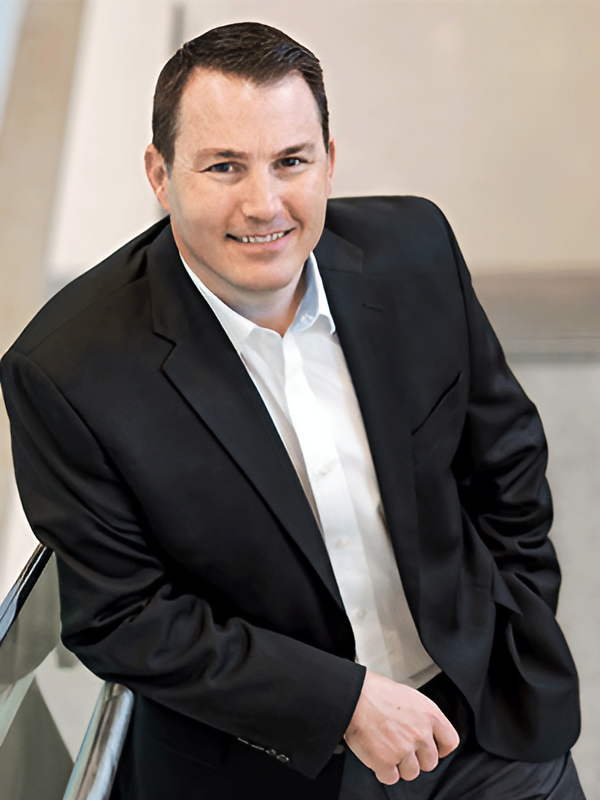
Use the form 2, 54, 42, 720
146, 69, 333, 305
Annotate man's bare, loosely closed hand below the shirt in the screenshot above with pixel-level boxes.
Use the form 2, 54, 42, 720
344, 670, 460, 784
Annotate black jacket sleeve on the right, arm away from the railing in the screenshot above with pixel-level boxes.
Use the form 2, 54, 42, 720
444, 206, 560, 612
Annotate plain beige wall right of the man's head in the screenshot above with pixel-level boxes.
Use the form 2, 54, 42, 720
187, 0, 600, 271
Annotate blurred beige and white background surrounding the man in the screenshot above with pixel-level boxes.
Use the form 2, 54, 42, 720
0, 0, 600, 800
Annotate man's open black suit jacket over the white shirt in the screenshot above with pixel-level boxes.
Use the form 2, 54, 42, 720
2, 198, 579, 797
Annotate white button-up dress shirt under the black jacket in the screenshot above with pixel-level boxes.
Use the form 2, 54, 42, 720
182, 254, 440, 687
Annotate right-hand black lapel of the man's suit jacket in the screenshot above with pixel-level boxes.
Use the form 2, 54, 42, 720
315, 230, 419, 618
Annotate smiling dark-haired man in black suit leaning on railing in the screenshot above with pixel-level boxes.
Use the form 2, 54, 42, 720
2, 23, 583, 800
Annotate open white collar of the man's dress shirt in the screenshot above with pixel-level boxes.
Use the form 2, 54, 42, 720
180, 253, 335, 353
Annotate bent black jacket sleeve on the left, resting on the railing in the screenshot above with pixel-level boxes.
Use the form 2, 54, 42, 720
1, 350, 365, 777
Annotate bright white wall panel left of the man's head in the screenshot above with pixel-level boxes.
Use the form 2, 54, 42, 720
48, 0, 171, 283
